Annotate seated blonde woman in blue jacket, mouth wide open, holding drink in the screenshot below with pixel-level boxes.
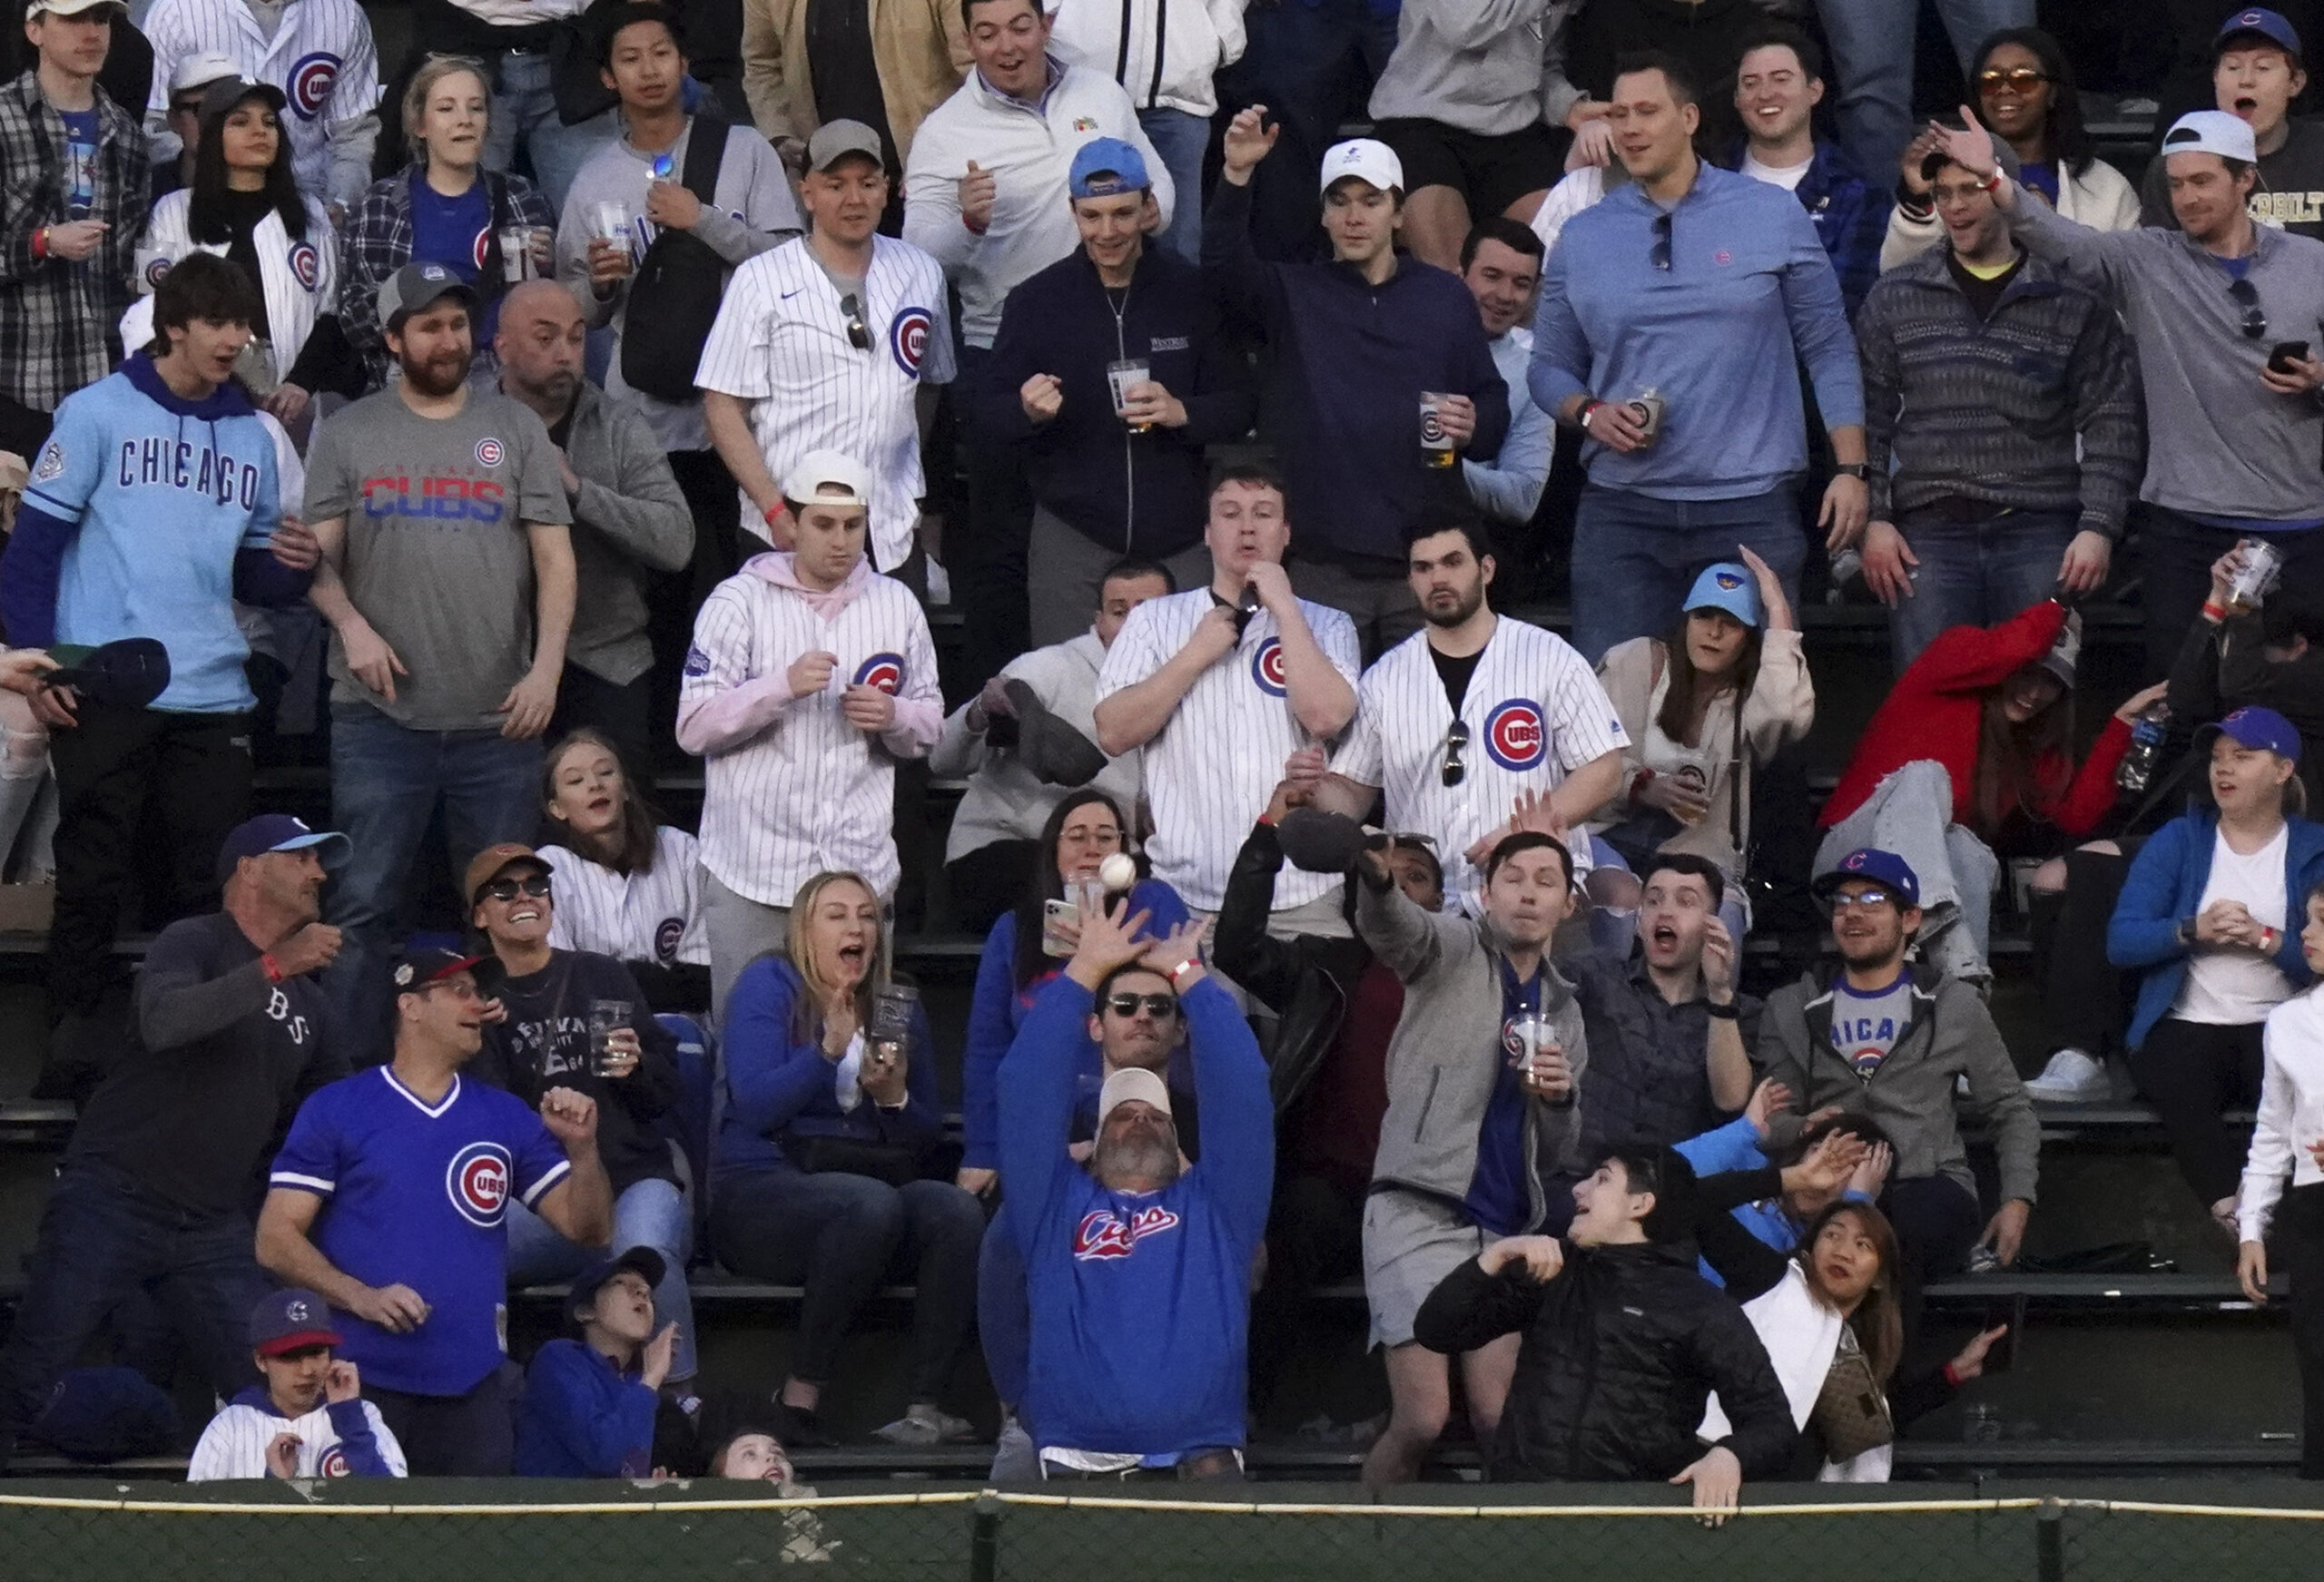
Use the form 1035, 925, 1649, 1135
711, 873, 985, 1448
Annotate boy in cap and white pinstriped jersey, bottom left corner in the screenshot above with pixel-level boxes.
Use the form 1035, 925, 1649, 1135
186, 1290, 409, 1482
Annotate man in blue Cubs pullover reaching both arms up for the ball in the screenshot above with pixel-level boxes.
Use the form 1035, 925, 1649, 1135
1001, 909, 1275, 1478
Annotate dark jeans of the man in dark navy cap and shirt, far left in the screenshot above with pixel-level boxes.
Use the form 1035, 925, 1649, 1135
0, 1159, 267, 1459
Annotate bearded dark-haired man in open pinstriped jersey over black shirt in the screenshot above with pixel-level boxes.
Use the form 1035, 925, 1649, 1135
1318, 516, 1630, 913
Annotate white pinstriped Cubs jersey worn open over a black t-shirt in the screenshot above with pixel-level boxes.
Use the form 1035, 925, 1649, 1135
1332, 615, 1630, 901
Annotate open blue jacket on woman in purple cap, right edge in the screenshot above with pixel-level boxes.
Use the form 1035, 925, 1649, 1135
2105, 806, 2324, 1050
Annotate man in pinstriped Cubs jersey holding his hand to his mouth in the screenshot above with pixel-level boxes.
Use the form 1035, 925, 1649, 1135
1097, 467, 1362, 936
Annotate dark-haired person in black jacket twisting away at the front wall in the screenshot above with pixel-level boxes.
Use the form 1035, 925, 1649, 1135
1413, 1147, 1798, 1521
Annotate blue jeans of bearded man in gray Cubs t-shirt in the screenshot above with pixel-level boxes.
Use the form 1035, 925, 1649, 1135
325, 704, 541, 1066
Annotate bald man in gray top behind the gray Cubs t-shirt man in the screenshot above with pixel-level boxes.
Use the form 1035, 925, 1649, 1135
493, 281, 694, 778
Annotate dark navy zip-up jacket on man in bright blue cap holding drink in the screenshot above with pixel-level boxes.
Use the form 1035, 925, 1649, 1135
976, 246, 1257, 560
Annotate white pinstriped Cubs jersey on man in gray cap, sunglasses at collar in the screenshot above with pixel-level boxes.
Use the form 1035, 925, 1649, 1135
687, 238, 953, 572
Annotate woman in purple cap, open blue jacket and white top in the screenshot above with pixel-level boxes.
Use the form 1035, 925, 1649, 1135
2105, 706, 2324, 1233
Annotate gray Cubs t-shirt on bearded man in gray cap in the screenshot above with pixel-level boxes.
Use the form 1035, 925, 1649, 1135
307, 386, 572, 730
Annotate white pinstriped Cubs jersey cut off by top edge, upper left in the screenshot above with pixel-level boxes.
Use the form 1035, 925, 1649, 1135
144, 0, 379, 202
